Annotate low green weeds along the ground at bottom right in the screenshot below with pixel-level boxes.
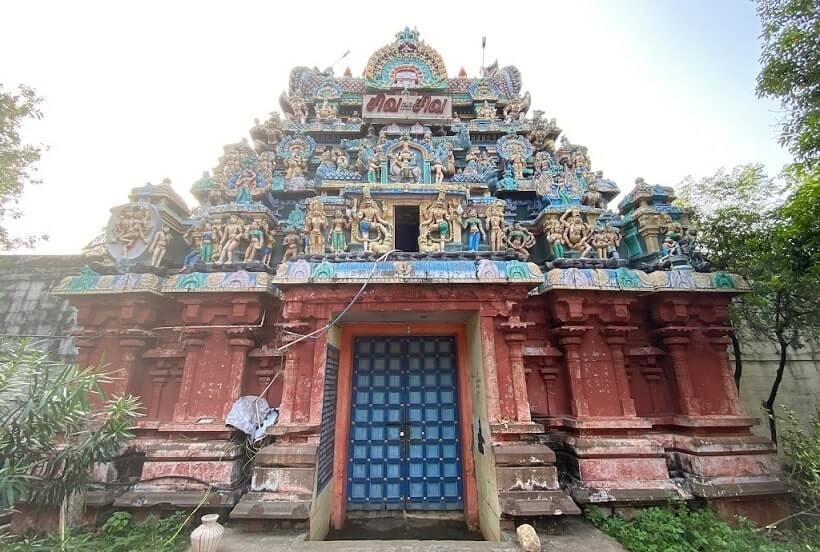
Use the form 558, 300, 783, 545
584, 505, 796, 552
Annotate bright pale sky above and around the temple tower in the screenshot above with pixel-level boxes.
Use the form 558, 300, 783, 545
0, 0, 790, 254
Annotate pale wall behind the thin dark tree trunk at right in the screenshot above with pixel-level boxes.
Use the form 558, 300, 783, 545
730, 336, 820, 437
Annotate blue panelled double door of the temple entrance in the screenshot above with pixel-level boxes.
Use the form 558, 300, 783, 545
347, 337, 463, 510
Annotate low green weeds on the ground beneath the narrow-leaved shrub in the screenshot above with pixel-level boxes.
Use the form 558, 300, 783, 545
2, 512, 190, 552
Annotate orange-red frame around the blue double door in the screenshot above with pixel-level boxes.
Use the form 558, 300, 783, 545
330, 322, 479, 529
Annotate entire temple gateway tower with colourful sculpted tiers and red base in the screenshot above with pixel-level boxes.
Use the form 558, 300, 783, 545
55, 28, 783, 540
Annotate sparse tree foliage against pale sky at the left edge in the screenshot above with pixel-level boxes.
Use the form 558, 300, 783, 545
0, 84, 47, 250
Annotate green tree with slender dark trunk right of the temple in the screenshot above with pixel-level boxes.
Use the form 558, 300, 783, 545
680, 165, 820, 443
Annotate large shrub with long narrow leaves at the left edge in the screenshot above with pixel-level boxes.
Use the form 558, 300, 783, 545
0, 340, 138, 508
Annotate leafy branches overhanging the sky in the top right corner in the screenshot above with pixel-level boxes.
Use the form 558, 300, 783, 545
757, 0, 820, 163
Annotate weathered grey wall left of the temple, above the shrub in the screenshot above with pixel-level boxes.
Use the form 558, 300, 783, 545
0, 255, 86, 360
